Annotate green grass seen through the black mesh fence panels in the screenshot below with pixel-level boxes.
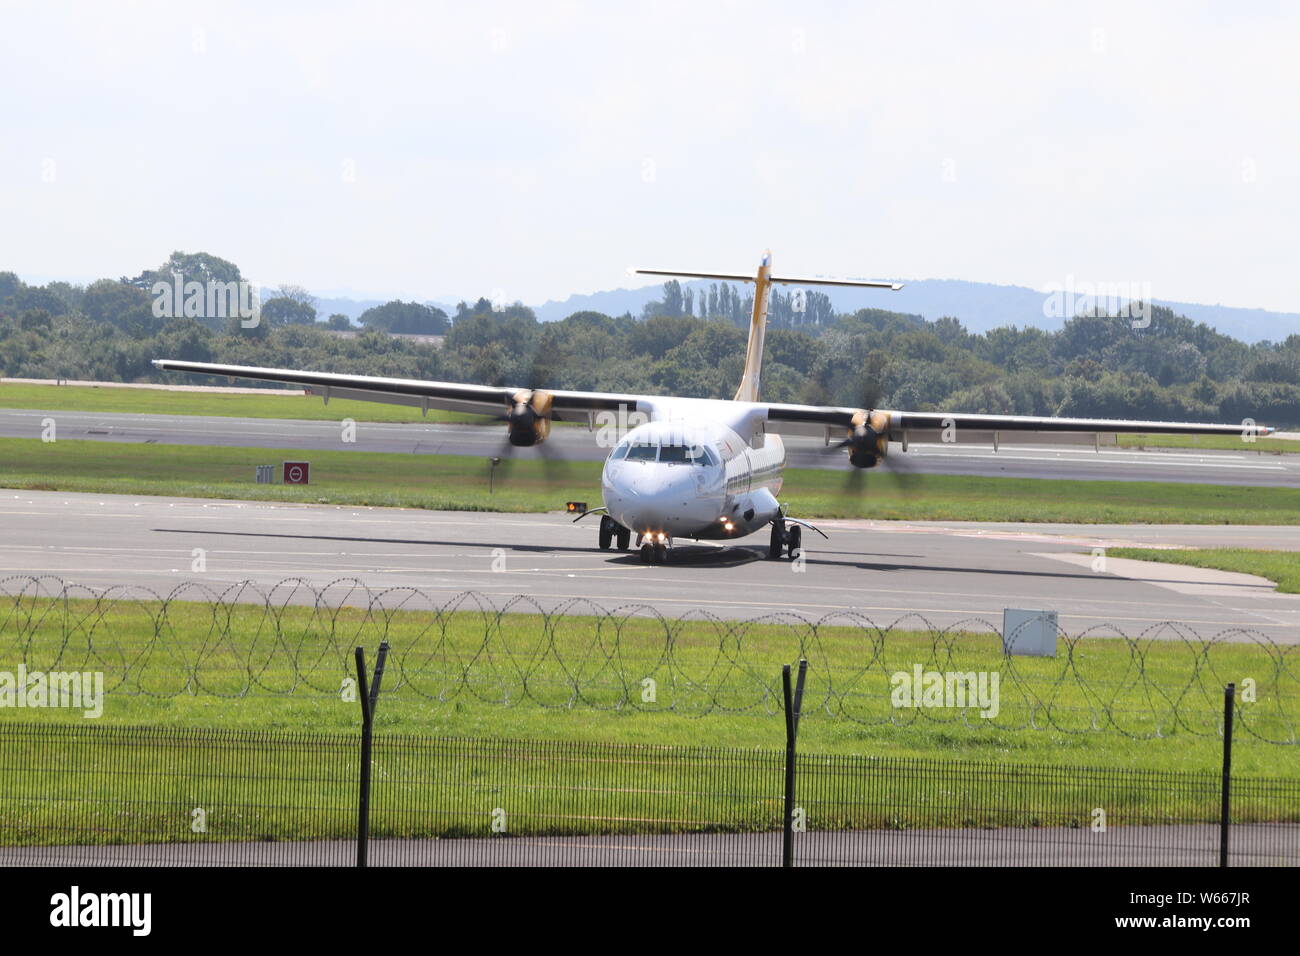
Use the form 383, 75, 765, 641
10, 722, 1284, 842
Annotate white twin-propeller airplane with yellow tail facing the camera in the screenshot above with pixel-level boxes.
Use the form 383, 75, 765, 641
153, 251, 1274, 564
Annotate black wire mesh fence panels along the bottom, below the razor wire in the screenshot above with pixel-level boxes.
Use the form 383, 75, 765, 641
0, 719, 1300, 866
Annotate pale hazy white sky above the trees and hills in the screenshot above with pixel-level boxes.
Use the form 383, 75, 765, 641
0, 0, 1300, 311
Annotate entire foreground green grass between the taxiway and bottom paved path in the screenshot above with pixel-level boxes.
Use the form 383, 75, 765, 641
0, 598, 1300, 844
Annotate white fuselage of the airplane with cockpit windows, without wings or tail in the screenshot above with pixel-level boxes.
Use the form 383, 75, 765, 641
601, 399, 785, 538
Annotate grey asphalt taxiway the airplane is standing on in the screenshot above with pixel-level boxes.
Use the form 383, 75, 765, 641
0, 490, 1300, 643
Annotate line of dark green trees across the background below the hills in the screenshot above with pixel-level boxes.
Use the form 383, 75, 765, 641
0, 252, 1300, 427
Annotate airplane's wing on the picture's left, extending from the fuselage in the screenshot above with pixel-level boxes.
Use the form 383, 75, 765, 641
153, 359, 647, 421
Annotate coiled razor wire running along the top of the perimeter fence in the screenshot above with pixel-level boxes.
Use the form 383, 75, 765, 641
0, 576, 1300, 745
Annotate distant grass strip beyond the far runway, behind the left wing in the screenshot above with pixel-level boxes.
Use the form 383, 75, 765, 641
0, 384, 495, 424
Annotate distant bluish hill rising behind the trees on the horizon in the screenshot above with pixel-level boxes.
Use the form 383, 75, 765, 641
533, 278, 1300, 342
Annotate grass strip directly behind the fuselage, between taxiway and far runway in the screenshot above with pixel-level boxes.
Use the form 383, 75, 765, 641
0, 438, 1300, 524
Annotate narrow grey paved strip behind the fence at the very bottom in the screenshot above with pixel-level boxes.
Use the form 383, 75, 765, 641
0, 823, 1300, 866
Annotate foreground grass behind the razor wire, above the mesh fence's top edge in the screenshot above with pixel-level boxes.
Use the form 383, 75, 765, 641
10, 598, 1300, 775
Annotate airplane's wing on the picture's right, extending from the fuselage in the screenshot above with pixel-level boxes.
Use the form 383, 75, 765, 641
764, 405, 1274, 444
